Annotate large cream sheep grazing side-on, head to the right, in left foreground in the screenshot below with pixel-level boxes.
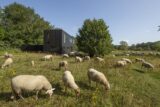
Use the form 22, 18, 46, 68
11, 75, 55, 100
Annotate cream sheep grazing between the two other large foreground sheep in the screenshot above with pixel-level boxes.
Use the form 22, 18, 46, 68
62, 71, 80, 96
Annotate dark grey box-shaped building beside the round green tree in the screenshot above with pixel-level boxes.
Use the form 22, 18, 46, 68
43, 29, 74, 54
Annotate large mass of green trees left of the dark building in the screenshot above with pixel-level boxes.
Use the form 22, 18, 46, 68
0, 3, 52, 47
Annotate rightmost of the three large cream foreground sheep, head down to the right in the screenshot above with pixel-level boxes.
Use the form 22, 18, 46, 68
87, 68, 110, 90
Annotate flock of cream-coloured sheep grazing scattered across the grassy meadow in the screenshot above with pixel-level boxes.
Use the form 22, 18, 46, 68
2, 53, 154, 99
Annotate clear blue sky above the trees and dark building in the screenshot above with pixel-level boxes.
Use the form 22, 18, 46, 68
0, 0, 160, 44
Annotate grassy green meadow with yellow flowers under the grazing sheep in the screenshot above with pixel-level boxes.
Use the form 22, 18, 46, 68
0, 51, 160, 107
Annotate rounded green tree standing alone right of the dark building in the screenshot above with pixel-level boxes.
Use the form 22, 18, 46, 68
76, 19, 112, 57
